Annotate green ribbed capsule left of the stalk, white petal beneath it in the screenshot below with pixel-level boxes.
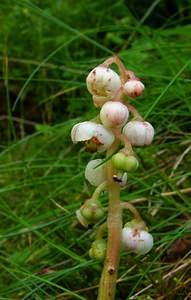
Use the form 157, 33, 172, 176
80, 199, 104, 223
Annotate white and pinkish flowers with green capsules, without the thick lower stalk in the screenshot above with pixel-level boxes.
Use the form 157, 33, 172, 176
71, 57, 154, 259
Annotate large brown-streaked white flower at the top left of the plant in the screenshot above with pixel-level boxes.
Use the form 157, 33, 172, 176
86, 66, 121, 99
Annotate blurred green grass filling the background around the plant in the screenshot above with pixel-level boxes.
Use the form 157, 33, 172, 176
0, 0, 191, 300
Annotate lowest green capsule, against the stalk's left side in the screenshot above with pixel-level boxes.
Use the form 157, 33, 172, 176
89, 239, 107, 261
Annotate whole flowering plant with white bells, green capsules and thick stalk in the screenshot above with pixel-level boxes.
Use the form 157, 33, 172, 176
71, 56, 154, 300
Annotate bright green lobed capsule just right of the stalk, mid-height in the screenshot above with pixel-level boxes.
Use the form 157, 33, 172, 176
112, 152, 139, 172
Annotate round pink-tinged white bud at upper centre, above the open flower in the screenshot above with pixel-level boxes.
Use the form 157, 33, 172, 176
100, 101, 129, 128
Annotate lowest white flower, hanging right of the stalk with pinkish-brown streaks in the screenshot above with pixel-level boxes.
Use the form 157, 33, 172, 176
122, 227, 153, 254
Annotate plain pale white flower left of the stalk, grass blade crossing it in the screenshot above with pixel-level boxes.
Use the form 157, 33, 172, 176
85, 159, 107, 186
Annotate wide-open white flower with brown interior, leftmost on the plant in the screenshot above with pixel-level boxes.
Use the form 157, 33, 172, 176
71, 121, 115, 152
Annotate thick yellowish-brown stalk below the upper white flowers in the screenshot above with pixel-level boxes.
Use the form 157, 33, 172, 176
97, 143, 122, 300
